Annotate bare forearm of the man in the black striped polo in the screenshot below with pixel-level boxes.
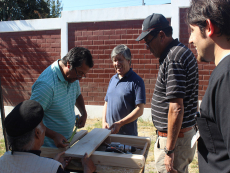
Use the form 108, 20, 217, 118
166, 98, 184, 150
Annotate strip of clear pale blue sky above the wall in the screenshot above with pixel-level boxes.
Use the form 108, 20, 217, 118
62, 0, 171, 11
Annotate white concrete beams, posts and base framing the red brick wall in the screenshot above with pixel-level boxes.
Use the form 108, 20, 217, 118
0, 0, 190, 120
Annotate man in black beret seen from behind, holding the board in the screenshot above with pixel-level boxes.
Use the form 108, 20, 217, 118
0, 100, 94, 173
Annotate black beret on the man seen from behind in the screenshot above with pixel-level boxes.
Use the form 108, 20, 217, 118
4, 100, 44, 137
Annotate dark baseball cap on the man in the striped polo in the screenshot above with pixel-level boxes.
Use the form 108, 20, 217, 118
136, 13, 170, 41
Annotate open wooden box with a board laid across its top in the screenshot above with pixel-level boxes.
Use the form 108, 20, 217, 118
41, 128, 151, 173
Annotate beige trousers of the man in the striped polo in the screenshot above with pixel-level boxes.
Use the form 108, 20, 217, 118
154, 129, 196, 173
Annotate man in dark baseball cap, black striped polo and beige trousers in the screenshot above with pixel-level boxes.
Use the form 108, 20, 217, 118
136, 13, 198, 173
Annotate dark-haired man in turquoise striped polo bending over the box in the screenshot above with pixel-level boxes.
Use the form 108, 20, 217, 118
30, 47, 93, 147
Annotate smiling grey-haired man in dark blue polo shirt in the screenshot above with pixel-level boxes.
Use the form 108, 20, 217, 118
102, 45, 146, 136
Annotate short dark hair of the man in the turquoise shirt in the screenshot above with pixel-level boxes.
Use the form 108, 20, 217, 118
61, 47, 93, 70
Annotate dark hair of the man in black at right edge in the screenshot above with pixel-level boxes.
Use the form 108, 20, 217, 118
187, 0, 230, 39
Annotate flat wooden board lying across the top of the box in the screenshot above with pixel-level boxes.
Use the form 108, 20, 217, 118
65, 128, 111, 158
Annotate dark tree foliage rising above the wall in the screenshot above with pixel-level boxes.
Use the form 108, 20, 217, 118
0, 0, 63, 21
